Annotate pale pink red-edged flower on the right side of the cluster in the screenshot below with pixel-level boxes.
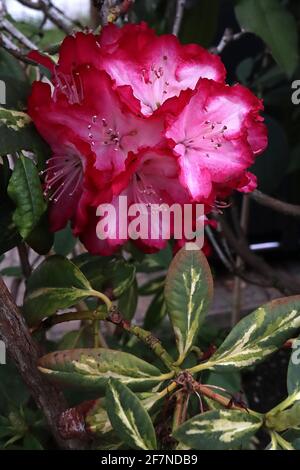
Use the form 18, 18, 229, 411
166, 79, 267, 201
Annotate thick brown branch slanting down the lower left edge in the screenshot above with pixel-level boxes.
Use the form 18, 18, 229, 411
0, 278, 86, 449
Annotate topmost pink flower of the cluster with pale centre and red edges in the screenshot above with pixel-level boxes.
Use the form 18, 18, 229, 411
100, 23, 226, 116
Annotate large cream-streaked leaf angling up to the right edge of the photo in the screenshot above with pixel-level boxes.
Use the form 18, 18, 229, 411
207, 296, 300, 371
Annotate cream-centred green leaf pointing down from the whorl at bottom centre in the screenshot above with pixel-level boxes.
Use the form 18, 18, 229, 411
106, 379, 157, 450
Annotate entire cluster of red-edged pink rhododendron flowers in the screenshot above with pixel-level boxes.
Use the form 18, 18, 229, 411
28, 23, 267, 254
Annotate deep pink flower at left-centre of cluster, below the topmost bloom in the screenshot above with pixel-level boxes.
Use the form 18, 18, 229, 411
29, 65, 163, 173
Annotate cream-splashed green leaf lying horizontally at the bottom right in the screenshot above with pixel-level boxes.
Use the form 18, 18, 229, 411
173, 410, 263, 450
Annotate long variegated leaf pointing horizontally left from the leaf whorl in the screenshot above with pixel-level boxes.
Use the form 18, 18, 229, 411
38, 348, 164, 393
